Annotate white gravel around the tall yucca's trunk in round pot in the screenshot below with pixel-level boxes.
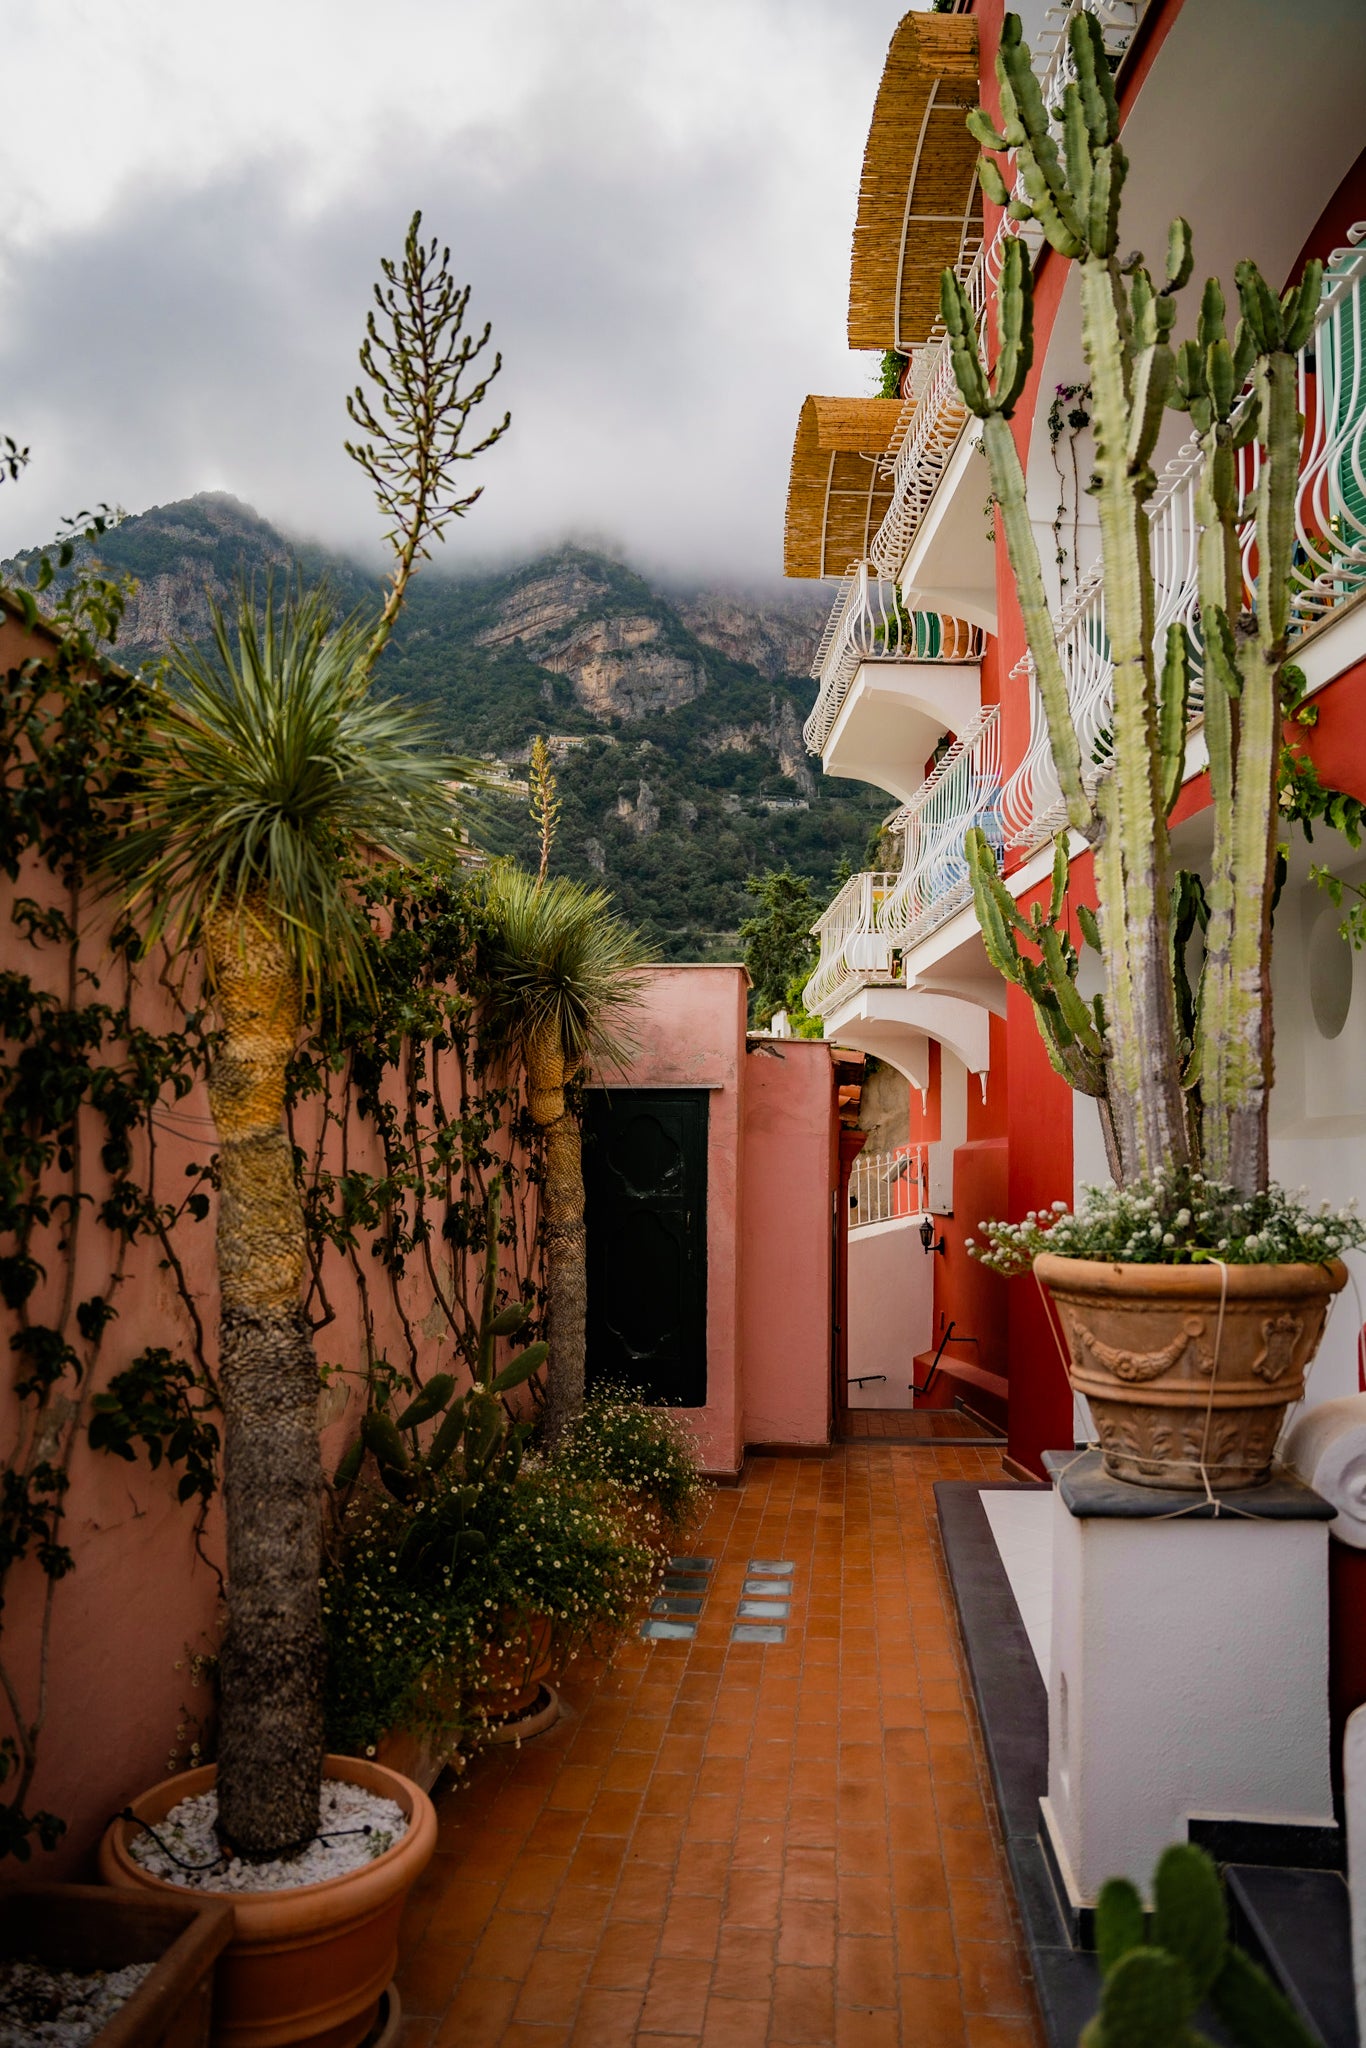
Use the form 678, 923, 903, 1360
127, 1778, 408, 1884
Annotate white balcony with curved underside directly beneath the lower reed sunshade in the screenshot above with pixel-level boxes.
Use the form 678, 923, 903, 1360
805, 561, 983, 803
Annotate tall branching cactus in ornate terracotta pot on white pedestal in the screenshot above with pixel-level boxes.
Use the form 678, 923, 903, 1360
942, 10, 1362, 1487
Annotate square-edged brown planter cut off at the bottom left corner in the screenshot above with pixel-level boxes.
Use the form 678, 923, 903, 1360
0, 1884, 233, 2048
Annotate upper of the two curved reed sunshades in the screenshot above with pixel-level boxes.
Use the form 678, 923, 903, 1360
850, 14, 981, 352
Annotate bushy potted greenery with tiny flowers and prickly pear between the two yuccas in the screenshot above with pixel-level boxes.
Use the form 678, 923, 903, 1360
324, 1184, 667, 1780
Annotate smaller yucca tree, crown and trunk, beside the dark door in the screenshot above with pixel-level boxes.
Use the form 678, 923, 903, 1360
485, 864, 645, 1442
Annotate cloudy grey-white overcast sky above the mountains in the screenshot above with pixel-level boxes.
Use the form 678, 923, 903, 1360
0, 0, 917, 582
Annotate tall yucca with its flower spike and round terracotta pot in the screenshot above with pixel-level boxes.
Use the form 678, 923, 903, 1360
102, 215, 508, 2048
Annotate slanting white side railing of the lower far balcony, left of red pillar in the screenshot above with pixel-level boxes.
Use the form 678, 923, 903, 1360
879, 705, 1001, 952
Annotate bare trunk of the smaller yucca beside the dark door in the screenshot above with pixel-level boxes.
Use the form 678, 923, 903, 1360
526, 1024, 588, 1444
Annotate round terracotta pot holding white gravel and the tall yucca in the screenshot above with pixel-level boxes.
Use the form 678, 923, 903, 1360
100, 1757, 436, 2048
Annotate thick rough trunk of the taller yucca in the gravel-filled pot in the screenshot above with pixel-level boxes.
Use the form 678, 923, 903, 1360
205, 901, 324, 1860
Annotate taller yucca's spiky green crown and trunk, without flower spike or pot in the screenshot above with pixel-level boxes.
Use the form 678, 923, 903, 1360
117, 592, 479, 1855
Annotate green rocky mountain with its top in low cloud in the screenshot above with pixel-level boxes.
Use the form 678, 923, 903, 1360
8, 494, 887, 961
